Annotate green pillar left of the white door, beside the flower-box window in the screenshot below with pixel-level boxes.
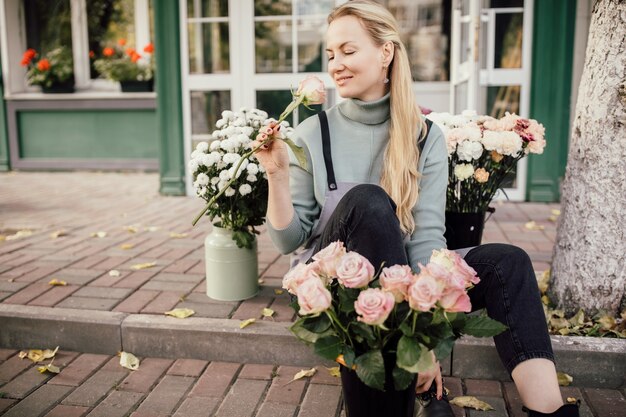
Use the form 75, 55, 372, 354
154, 0, 185, 195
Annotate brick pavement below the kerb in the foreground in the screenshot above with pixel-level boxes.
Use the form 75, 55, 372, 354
0, 349, 626, 417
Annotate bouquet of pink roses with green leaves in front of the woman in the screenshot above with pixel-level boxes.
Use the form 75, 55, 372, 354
283, 241, 506, 390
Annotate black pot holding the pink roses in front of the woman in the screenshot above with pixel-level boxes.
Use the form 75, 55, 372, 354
340, 356, 417, 417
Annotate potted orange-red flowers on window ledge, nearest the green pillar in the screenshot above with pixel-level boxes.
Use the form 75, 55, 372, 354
94, 39, 154, 92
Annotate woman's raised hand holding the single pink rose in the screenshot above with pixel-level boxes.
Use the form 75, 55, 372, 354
252, 122, 289, 177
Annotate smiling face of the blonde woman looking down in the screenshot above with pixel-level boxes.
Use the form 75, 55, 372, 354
326, 16, 390, 101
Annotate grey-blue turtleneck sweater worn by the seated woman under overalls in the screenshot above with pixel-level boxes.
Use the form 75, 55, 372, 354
267, 94, 448, 271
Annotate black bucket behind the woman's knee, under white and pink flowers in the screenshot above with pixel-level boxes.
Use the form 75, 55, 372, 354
444, 207, 495, 249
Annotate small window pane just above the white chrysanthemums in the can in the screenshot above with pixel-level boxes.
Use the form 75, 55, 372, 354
191, 91, 230, 135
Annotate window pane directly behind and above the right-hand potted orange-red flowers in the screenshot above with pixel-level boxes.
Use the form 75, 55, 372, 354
87, 0, 136, 78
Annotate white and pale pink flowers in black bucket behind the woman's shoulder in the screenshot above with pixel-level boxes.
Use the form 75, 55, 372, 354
426, 111, 546, 213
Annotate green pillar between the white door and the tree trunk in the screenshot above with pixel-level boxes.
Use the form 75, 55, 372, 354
526, 0, 576, 202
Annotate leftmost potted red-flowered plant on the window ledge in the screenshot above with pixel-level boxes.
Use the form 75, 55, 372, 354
21, 47, 74, 93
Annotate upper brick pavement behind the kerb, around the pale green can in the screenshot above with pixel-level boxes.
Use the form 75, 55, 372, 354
0, 172, 558, 321
